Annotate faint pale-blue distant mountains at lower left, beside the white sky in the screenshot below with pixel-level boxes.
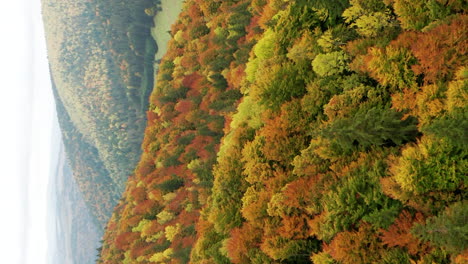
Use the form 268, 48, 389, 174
48, 137, 102, 264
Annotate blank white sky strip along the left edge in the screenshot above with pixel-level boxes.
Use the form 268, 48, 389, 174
0, 0, 55, 264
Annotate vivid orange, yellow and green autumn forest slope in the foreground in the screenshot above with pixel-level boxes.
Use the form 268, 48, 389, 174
98, 0, 468, 264
